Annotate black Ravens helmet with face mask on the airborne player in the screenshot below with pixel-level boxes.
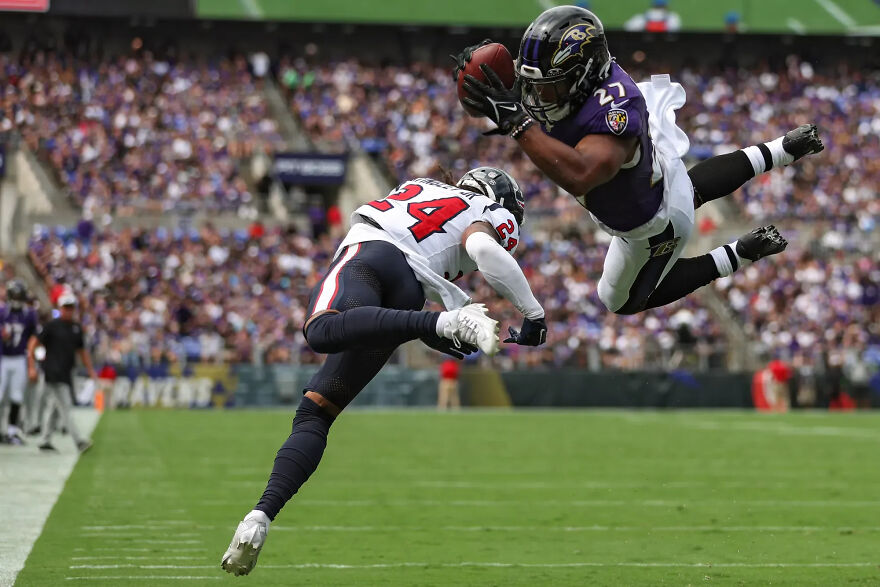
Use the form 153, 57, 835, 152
516, 6, 612, 126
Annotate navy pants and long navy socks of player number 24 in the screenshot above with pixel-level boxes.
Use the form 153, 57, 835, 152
255, 241, 439, 520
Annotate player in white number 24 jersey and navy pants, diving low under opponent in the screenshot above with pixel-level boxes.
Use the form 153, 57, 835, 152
221, 167, 547, 575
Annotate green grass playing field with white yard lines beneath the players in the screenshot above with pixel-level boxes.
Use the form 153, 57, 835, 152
17, 410, 880, 586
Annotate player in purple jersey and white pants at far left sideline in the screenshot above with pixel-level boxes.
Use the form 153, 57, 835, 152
0, 281, 37, 444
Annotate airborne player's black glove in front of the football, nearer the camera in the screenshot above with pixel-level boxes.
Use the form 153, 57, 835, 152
462, 63, 529, 135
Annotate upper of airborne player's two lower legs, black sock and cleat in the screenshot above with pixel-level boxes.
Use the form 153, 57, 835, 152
688, 124, 825, 208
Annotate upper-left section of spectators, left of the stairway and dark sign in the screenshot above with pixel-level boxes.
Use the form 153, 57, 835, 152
0, 51, 284, 218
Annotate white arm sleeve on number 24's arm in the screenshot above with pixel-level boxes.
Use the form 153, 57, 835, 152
465, 232, 544, 320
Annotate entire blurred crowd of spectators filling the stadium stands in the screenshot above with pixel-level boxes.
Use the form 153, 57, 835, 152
0, 42, 880, 382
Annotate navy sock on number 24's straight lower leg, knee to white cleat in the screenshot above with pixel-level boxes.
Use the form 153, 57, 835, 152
254, 397, 335, 520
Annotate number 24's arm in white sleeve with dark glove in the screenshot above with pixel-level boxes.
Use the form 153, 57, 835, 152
461, 222, 547, 346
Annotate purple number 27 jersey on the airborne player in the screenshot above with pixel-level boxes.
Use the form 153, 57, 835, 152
547, 63, 663, 231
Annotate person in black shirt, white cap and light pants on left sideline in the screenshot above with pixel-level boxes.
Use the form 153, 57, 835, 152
28, 292, 96, 453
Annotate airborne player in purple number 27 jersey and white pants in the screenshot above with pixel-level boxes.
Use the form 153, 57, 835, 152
453, 6, 824, 314
